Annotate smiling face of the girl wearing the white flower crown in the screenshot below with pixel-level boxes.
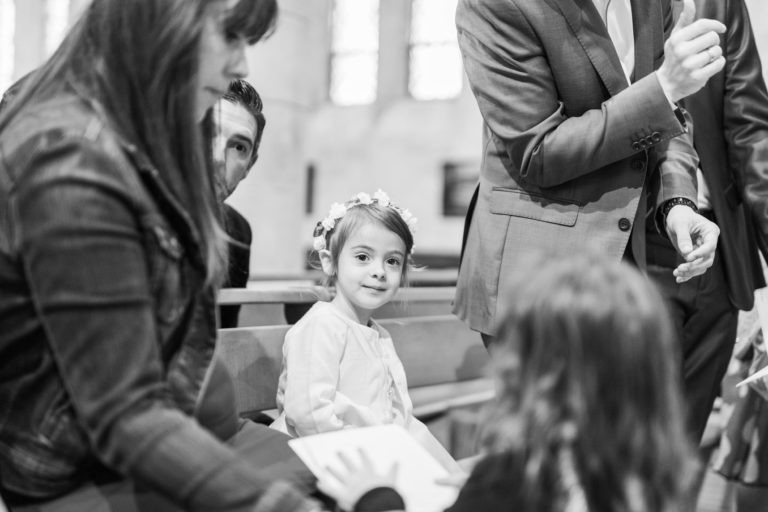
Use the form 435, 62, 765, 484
320, 222, 405, 324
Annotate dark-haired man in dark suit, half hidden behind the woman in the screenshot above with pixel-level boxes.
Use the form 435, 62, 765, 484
213, 79, 266, 328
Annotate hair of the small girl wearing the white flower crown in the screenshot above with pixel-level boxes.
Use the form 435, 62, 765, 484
310, 202, 413, 286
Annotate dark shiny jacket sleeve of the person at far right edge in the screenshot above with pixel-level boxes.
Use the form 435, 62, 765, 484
723, 0, 768, 256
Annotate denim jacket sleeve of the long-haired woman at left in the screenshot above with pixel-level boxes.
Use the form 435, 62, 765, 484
10, 137, 314, 510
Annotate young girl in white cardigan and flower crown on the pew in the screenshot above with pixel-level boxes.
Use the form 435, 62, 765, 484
272, 190, 452, 462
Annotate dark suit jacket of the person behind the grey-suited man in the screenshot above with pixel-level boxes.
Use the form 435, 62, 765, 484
676, 0, 768, 310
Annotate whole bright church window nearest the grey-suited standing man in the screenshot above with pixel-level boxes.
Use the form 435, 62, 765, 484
408, 0, 463, 100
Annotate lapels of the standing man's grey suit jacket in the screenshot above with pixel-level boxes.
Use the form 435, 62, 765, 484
547, 0, 632, 96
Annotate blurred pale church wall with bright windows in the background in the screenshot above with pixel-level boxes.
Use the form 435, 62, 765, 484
0, 0, 768, 280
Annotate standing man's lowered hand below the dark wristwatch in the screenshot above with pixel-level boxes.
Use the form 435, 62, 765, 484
666, 205, 720, 283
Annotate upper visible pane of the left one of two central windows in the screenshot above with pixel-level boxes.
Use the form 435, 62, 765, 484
331, 0, 379, 52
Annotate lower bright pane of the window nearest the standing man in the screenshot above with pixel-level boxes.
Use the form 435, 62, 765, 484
408, 44, 462, 100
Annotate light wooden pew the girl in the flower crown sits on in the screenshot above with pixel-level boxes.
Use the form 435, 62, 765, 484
217, 315, 493, 418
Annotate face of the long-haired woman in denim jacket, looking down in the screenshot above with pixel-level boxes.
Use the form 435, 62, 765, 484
195, 0, 248, 120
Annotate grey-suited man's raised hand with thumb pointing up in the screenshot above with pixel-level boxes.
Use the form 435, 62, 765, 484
656, 0, 725, 102
